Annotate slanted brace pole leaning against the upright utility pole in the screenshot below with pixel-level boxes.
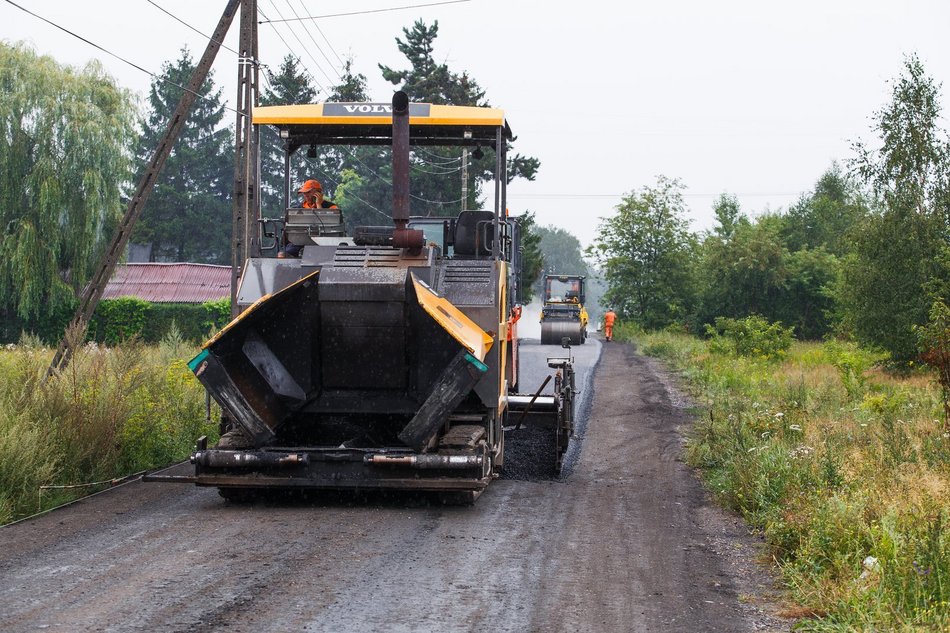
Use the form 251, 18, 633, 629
46, 0, 244, 378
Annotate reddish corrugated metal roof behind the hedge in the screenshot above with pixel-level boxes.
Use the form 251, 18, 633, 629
102, 263, 231, 303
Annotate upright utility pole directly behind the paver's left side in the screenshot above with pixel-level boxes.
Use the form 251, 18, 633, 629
231, 0, 261, 317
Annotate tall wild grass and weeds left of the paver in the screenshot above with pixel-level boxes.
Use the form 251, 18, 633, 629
0, 335, 217, 525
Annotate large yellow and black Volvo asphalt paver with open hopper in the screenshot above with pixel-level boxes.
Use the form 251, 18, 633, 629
155, 93, 573, 502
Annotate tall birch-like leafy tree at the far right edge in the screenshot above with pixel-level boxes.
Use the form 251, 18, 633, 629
839, 56, 950, 361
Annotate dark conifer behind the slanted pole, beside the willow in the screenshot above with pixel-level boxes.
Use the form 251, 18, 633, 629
131, 49, 234, 264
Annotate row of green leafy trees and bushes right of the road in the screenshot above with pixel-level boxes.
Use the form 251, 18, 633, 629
588, 56, 950, 361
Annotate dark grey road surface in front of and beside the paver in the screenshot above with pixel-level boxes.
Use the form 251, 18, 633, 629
0, 339, 791, 633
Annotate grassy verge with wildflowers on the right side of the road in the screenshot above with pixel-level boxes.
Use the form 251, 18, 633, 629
617, 329, 950, 631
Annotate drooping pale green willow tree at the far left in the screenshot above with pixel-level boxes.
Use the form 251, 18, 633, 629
0, 43, 135, 338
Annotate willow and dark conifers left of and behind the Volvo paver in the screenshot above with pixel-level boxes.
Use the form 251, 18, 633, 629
0, 20, 541, 341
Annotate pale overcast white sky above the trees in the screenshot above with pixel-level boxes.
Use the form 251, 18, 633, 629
0, 0, 950, 244
